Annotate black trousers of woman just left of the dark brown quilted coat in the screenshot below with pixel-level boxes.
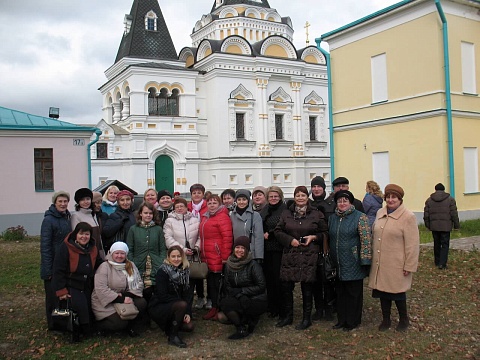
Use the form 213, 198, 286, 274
263, 251, 282, 314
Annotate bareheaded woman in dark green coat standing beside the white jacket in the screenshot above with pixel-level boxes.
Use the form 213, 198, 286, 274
127, 202, 167, 301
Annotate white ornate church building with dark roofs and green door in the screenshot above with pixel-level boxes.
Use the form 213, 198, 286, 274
91, 0, 331, 196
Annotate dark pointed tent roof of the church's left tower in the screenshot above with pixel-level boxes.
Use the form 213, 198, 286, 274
115, 0, 178, 62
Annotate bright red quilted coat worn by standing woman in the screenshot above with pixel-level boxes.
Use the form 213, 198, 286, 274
198, 205, 233, 272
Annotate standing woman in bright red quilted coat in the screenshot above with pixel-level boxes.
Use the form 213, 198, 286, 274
198, 194, 233, 320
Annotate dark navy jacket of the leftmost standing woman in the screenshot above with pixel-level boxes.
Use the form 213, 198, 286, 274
40, 204, 72, 280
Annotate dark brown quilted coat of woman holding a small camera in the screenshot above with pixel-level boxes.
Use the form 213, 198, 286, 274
275, 204, 327, 282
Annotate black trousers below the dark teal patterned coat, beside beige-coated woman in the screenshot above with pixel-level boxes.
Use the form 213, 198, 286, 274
336, 279, 363, 328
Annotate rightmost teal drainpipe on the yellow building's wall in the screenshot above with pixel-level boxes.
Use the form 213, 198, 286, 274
435, 0, 455, 197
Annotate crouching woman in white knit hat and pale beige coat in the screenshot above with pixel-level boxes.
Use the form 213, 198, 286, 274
92, 241, 147, 337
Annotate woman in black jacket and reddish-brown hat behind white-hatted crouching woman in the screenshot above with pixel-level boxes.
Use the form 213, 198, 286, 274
102, 190, 136, 252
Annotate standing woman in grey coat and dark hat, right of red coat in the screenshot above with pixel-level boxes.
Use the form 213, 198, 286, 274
230, 189, 264, 261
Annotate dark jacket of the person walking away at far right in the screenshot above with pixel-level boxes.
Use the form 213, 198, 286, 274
423, 190, 460, 232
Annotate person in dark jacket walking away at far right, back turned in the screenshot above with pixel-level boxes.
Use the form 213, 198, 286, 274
423, 183, 460, 270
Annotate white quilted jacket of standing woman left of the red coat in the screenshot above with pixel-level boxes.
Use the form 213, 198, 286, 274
163, 211, 200, 249
